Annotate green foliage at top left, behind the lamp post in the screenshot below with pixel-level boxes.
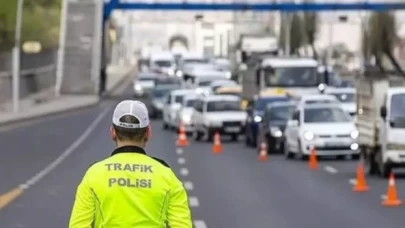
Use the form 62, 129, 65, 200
0, 0, 61, 51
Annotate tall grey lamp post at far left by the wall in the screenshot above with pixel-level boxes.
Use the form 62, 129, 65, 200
12, 0, 24, 113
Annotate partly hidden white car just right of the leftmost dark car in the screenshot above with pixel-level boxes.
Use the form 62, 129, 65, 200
162, 89, 195, 129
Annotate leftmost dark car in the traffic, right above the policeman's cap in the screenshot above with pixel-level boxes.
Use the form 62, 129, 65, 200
149, 84, 181, 118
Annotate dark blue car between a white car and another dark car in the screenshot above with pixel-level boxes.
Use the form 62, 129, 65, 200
245, 96, 291, 147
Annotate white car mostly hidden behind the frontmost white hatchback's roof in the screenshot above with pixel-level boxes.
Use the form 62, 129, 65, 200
325, 87, 356, 116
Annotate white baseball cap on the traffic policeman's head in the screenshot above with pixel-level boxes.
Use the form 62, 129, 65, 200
112, 100, 149, 129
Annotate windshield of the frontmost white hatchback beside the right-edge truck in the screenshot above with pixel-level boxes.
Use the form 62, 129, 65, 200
304, 107, 353, 123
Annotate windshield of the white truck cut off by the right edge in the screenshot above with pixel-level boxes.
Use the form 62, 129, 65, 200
390, 94, 405, 128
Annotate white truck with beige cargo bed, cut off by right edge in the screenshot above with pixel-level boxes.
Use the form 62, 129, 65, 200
356, 76, 405, 177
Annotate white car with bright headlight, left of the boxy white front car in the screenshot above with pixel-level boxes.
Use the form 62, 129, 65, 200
175, 94, 199, 133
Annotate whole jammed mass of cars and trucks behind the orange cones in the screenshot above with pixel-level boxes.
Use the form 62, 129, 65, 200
135, 51, 405, 176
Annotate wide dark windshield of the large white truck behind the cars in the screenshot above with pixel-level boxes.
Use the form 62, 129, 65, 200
264, 67, 319, 87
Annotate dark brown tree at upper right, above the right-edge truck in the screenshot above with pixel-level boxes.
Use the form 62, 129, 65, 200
364, 12, 405, 76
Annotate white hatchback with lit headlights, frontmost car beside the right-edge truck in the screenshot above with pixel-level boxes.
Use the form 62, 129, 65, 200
284, 104, 359, 158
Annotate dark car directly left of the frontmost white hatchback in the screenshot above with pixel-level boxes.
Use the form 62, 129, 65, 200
257, 101, 297, 154
